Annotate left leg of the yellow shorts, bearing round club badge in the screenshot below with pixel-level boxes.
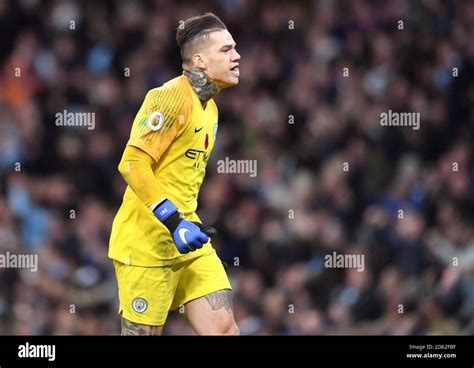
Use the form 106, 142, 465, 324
114, 261, 183, 326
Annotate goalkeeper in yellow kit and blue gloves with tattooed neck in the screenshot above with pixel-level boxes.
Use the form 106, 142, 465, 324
109, 13, 240, 335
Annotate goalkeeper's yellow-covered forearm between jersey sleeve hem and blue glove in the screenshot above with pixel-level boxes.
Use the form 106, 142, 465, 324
118, 146, 162, 207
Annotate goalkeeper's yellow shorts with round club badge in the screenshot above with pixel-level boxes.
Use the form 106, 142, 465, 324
114, 251, 231, 326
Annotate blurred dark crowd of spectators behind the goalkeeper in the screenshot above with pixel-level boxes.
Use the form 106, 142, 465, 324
0, 0, 474, 335
